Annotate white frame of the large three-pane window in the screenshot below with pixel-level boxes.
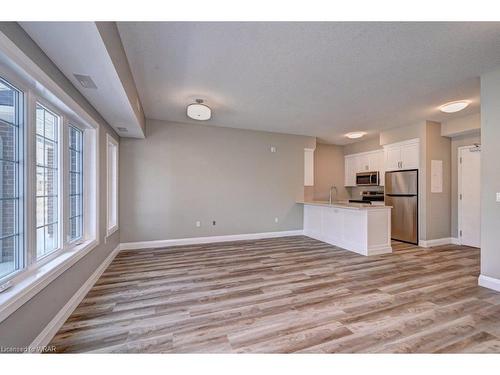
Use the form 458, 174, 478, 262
0, 53, 101, 322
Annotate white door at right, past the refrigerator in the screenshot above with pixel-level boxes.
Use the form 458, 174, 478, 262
458, 147, 481, 247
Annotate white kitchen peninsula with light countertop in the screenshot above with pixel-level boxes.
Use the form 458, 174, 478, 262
297, 201, 392, 255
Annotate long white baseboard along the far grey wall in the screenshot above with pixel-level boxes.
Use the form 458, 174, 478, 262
120, 229, 303, 250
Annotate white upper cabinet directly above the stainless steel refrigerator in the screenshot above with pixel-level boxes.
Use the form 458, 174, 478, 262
384, 139, 420, 171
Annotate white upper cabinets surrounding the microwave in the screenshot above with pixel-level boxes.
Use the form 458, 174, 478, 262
344, 150, 384, 186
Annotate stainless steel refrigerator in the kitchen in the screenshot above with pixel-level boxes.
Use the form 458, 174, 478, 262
385, 169, 418, 244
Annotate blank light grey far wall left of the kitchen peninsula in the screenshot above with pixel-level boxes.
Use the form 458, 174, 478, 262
120, 121, 311, 242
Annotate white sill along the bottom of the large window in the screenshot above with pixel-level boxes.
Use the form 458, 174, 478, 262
0, 240, 99, 322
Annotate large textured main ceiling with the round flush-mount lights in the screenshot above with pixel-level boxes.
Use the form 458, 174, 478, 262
118, 22, 500, 144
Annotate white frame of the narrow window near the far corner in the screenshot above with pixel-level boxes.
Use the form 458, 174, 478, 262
106, 133, 120, 237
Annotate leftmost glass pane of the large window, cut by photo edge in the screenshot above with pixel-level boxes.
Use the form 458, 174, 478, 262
0, 78, 24, 279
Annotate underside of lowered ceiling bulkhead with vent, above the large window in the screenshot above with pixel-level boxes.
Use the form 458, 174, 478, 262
20, 22, 144, 138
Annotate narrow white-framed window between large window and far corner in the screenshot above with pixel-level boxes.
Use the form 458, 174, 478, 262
107, 135, 118, 236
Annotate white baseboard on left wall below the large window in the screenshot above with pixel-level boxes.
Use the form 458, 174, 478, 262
30, 245, 120, 351
